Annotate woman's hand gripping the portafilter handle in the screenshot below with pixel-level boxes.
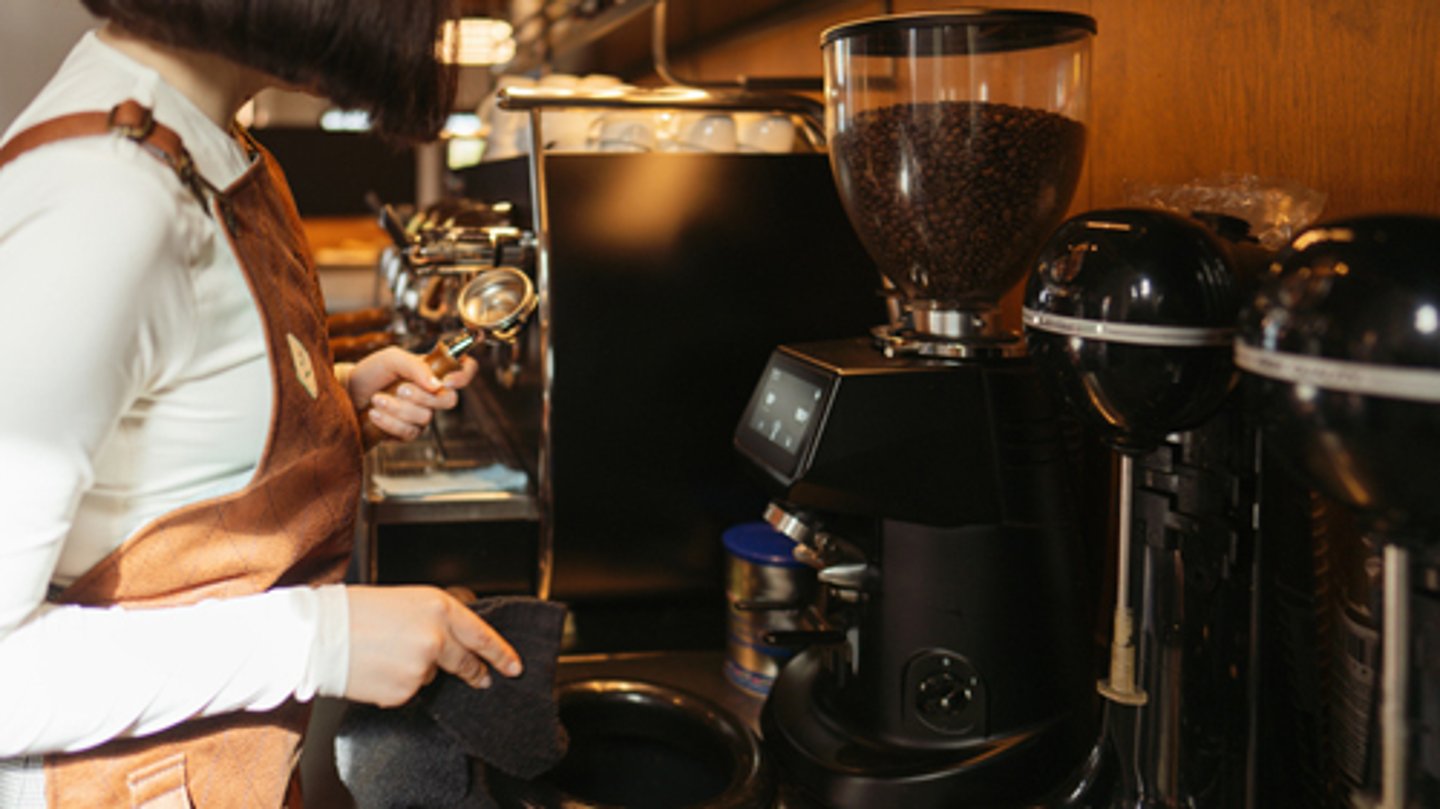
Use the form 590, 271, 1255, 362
346, 345, 480, 440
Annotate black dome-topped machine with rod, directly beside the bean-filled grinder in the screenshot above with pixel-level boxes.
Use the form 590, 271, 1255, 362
1024, 209, 1269, 809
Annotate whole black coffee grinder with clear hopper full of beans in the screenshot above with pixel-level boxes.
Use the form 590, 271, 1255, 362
734, 10, 1097, 808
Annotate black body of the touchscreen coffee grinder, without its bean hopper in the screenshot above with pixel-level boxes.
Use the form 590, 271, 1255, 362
736, 338, 1094, 806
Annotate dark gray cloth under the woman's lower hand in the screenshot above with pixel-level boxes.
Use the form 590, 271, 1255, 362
336, 596, 569, 809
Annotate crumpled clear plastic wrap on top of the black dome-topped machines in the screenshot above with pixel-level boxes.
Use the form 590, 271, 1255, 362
1126, 168, 1325, 250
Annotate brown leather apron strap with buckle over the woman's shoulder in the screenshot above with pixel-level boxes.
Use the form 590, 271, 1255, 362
0, 99, 216, 213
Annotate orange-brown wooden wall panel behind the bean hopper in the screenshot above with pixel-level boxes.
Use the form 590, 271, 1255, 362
662, 0, 1440, 216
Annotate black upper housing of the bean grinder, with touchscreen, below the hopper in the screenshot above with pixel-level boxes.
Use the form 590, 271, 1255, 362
736, 337, 1066, 525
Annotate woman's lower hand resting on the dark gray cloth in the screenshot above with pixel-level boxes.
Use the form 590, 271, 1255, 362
346, 586, 521, 708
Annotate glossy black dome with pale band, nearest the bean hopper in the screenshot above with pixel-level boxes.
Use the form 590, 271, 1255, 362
1024, 209, 1240, 452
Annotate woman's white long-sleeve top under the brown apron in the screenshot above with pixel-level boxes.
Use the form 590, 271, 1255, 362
0, 32, 348, 808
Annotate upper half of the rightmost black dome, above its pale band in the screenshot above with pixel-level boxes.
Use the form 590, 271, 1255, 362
1240, 214, 1440, 369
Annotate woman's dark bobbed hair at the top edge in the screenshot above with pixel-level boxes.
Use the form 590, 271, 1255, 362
82, 0, 455, 140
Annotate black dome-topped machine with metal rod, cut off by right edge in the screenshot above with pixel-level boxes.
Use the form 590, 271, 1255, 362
1236, 216, 1440, 809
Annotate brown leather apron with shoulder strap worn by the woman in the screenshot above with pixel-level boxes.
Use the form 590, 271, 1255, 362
0, 102, 361, 809
